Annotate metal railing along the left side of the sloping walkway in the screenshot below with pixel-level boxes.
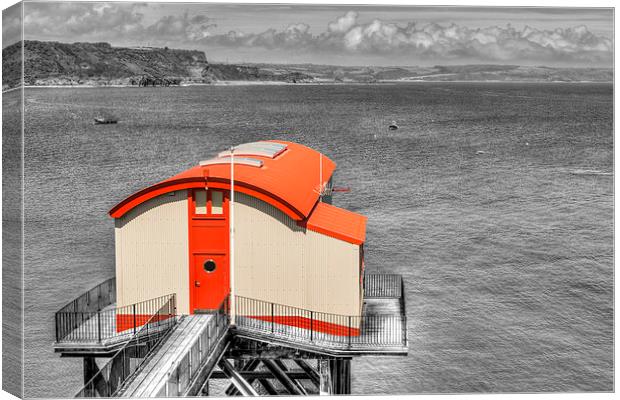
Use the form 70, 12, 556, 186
75, 294, 177, 397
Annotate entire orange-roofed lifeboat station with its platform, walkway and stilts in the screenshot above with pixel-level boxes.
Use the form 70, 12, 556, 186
54, 141, 408, 397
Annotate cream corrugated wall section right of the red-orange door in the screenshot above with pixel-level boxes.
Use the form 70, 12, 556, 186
235, 193, 361, 315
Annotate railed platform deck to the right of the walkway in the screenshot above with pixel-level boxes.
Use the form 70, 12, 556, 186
235, 274, 408, 356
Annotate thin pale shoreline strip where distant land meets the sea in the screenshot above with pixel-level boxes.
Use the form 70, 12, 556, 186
2, 79, 613, 93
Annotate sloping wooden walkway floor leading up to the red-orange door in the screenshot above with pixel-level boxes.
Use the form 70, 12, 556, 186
119, 314, 215, 397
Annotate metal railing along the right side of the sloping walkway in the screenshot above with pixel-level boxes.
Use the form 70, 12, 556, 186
162, 296, 229, 397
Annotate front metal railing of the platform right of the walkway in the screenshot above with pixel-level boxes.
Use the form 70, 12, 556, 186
235, 296, 406, 349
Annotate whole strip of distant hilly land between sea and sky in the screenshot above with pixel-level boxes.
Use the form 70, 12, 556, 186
2, 40, 613, 90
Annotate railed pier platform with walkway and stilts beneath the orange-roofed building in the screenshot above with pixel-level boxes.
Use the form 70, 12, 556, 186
54, 274, 408, 397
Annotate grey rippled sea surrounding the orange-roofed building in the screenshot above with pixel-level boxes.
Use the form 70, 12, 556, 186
17, 83, 613, 397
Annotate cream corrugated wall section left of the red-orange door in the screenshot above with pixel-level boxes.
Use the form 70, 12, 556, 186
114, 190, 189, 314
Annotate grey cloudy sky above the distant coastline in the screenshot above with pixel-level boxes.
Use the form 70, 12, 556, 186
3, 2, 613, 67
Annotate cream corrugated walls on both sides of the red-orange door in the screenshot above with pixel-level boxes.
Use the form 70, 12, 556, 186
115, 190, 362, 315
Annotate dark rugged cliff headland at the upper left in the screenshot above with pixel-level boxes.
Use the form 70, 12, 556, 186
2, 40, 312, 89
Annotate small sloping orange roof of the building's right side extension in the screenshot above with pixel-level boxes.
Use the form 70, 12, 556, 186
306, 203, 367, 244
